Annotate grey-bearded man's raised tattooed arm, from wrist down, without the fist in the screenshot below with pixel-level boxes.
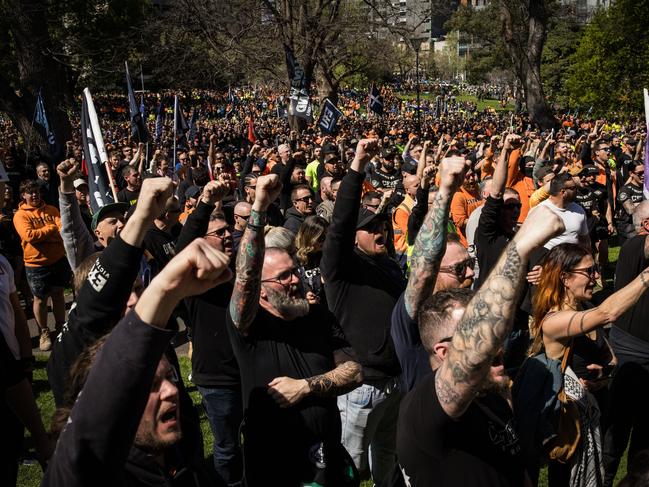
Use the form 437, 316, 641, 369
230, 210, 266, 333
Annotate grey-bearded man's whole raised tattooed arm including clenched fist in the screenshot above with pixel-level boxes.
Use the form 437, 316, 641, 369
230, 174, 282, 335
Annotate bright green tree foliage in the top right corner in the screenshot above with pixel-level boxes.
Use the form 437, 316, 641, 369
566, 0, 649, 114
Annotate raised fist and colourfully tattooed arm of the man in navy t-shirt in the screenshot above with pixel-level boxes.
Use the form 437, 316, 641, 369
405, 157, 468, 319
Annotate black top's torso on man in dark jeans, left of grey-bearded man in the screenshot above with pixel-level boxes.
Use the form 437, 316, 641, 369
185, 283, 240, 387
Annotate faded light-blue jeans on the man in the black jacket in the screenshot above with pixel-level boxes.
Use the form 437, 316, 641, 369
338, 378, 403, 486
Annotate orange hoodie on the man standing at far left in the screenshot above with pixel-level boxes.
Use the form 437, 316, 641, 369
14, 203, 65, 267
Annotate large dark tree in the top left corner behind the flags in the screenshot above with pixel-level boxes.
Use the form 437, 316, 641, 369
0, 0, 146, 158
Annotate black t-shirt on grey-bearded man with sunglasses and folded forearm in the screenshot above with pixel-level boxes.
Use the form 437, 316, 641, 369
226, 305, 349, 484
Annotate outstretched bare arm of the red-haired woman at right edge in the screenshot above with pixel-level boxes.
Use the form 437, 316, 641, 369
543, 267, 649, 340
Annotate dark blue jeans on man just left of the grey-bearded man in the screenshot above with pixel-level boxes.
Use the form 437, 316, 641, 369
198, 386, 243, 486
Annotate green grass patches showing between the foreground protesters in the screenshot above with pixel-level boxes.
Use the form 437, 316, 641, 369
18, 247, 626, 487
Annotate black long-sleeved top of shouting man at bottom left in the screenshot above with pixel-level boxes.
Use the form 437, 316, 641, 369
42, 312, 215, 487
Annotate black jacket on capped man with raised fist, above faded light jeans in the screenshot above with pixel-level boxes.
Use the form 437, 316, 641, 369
320, 170, 406, 382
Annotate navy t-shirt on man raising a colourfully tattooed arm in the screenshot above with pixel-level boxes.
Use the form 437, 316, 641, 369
390, 294, 431, 392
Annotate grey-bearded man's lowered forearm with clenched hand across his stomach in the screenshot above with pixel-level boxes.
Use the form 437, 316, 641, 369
268, 350, 363, 408
